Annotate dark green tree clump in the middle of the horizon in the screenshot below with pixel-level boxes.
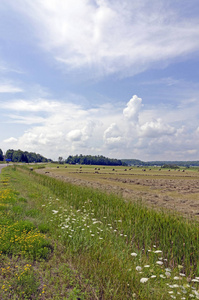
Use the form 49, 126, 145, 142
65, 154, 127, 166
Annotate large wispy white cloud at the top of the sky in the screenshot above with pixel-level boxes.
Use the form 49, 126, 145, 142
9, 0, 199, 76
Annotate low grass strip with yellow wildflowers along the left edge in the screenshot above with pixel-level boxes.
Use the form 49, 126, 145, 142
0, 172, 95, 300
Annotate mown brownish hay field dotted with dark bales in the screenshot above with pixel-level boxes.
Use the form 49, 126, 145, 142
37, 166, 199, 220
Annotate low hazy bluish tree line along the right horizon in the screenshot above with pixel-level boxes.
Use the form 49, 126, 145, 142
121, 159, 199, 168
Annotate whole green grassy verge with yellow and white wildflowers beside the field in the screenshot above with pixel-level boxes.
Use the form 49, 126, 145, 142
0, 165, 199, 300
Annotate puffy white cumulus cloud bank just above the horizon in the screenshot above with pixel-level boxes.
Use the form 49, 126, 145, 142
2, 95, 199, 160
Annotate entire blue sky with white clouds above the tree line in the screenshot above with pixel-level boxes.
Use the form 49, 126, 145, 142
0, 0, 199, 161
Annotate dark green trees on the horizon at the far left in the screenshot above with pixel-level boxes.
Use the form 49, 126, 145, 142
0, 149, 51, 163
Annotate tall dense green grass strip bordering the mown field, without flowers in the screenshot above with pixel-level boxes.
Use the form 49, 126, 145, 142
23, 165, 199, 276
